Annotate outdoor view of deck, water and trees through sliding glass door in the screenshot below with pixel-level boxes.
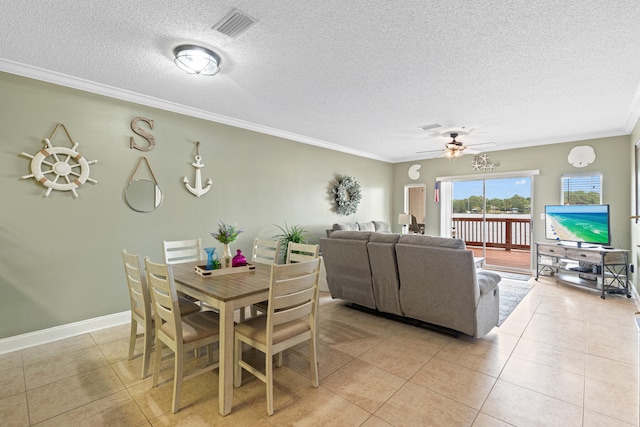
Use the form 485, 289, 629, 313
451, 176, 531, 272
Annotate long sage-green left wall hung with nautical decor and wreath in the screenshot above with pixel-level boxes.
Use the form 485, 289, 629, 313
0, 73, 393, 338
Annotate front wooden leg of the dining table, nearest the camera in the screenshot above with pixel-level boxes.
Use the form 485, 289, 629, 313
218, 304, 234, 415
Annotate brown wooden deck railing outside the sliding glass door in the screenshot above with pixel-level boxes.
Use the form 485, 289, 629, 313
453, 216, 531, 251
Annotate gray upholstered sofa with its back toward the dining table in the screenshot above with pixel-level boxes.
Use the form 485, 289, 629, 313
320, 230, 500, 338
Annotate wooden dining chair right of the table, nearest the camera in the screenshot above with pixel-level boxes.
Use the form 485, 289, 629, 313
234, 259, 320, 415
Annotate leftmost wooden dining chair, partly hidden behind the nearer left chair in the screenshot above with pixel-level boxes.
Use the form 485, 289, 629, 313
122, 249, 200, 378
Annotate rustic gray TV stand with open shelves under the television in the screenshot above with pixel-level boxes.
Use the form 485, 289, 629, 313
536, 243, 631, 299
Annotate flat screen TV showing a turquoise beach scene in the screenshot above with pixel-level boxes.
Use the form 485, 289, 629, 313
544, 205, 611, 247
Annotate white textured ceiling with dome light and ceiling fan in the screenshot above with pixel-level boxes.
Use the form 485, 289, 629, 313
0, 0, 640, 162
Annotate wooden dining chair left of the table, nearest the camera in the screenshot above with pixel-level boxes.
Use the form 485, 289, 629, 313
144, 257, 220, 414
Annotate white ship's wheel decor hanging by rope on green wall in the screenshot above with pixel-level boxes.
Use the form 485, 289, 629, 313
21, 123, 98, 198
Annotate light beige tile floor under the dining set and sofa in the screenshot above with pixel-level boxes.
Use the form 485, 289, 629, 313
0, 278, 638, 427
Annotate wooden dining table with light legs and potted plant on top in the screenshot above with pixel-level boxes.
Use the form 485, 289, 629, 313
171, 261, 269, 415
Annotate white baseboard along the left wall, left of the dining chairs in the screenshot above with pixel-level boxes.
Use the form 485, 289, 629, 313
0, 310, 131, 354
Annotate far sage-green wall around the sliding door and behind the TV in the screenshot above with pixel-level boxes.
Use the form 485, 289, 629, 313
392, 135, 632, 270
